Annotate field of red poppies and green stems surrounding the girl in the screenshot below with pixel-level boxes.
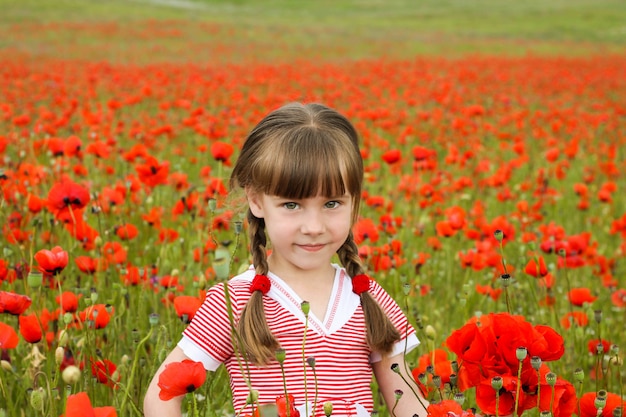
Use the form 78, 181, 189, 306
0, 0, 626, 417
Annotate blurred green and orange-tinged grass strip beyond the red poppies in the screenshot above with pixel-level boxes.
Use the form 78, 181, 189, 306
0, 0, 626, 62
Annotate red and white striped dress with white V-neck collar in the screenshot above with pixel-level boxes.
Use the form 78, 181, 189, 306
178, 265, 419, 417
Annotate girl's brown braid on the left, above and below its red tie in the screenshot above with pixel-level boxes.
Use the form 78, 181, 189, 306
238, 211, 280, 365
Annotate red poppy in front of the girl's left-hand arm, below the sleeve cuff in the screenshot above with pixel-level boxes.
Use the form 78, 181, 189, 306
158, 359, 207, 401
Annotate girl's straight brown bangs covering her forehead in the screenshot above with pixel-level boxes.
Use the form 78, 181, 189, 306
254, 126, 362, 199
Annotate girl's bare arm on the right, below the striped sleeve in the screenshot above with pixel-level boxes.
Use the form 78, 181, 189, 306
372, 353, 428, 417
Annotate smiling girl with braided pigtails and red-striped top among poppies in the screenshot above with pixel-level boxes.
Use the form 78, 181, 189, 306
144, 103, 427, 417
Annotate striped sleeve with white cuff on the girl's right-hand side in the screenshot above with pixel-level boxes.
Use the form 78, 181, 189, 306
370, 282, 420, 362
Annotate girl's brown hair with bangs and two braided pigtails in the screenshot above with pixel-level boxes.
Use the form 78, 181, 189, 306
230, 103, 400, 365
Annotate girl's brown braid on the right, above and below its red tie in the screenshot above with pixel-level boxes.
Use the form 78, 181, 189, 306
337, 232, 401, 353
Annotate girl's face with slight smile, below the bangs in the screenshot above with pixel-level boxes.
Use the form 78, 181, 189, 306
247, 192, 353, 278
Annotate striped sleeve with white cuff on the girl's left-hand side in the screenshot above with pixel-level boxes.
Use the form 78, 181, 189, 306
178, 283, 242, 371
